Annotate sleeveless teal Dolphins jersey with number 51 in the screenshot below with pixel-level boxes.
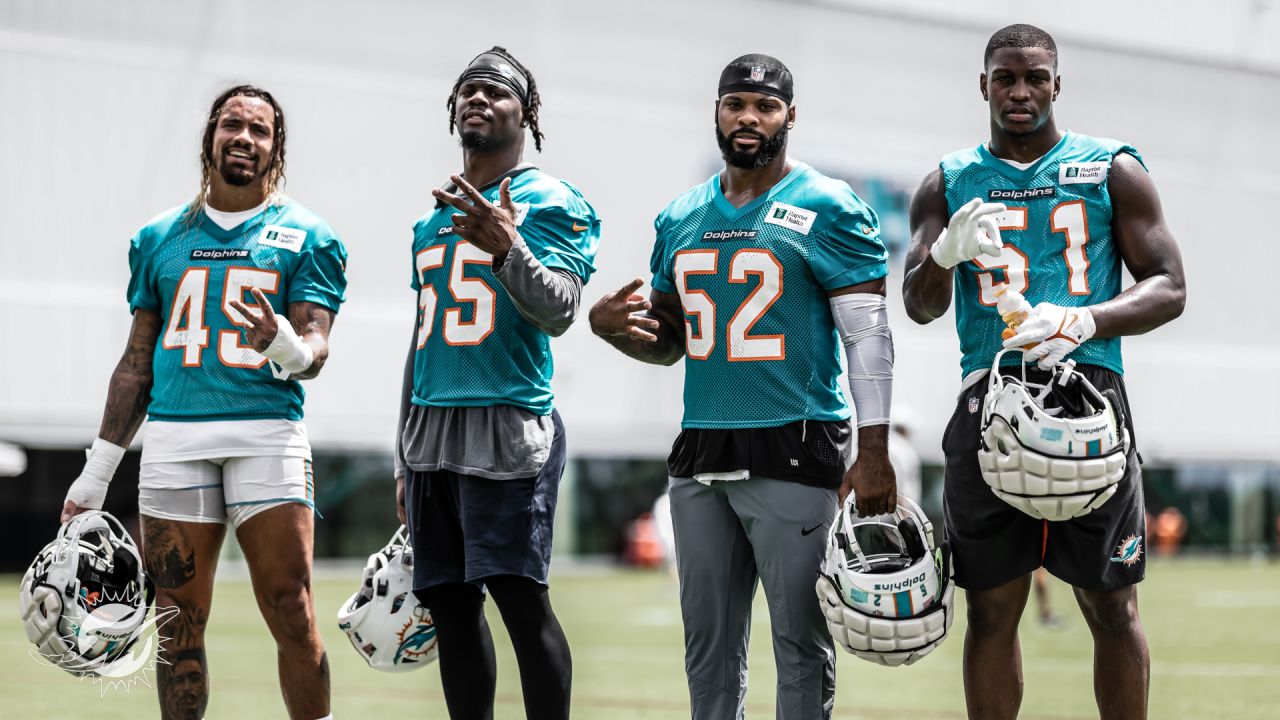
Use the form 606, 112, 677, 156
941, 132, 1142, 375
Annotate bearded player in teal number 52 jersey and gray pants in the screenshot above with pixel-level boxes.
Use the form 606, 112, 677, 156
590, 54, 896, 719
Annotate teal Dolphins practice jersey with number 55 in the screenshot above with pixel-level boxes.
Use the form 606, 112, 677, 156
412, 168, 600, 415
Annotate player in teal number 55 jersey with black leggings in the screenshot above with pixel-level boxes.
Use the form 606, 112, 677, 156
396, 47, 600, 719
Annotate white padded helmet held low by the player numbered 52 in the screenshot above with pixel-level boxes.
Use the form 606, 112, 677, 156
817, 495, 955, 666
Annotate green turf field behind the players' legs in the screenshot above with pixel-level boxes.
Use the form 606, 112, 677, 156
0, 561, 1280, 720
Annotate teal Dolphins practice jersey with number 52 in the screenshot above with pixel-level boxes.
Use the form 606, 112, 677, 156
650, 164, 888, 428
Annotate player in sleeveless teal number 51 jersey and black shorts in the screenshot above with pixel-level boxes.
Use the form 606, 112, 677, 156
902, 24, 1185, 719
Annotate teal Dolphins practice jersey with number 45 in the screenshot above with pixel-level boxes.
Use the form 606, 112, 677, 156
128, 200, 347, 420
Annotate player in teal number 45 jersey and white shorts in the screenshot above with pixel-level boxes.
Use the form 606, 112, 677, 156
63, 86, 347, 720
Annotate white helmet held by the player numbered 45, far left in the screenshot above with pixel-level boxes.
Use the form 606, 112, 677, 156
18, 510, 155, 675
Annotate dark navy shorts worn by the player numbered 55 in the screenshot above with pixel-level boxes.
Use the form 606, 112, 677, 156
404, 411, 564, 591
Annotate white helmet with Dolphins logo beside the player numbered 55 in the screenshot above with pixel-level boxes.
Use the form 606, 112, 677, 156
338, 525, 439, 673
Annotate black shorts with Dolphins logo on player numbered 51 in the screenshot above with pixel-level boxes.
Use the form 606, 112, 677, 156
942, 365, 1147, 591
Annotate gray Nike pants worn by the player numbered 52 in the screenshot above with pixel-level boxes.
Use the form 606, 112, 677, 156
671, 477, 836, 720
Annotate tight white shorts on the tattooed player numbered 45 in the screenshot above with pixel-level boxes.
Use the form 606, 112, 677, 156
138, 456, 315, 528
